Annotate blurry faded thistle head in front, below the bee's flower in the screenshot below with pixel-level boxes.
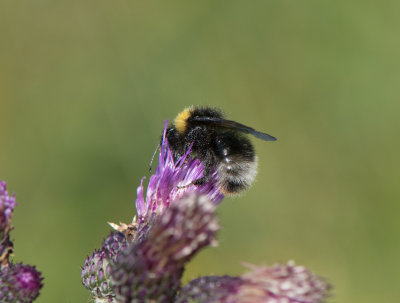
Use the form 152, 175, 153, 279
111, 194, 219, 303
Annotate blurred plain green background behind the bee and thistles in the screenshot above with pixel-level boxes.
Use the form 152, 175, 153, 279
0, 0, 400, 303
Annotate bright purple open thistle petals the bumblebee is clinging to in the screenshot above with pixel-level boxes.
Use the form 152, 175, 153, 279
136, 122, 224, 224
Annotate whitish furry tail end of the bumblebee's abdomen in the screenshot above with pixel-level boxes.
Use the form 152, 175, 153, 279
217, 156, 257, 195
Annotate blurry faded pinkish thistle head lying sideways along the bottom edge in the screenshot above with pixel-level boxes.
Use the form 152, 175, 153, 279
176, 262, 330, 303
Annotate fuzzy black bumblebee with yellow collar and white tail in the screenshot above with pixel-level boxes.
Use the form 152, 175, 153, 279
162, 106, 276, 195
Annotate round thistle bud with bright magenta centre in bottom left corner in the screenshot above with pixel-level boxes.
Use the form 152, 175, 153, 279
0, 264, 43, 303
